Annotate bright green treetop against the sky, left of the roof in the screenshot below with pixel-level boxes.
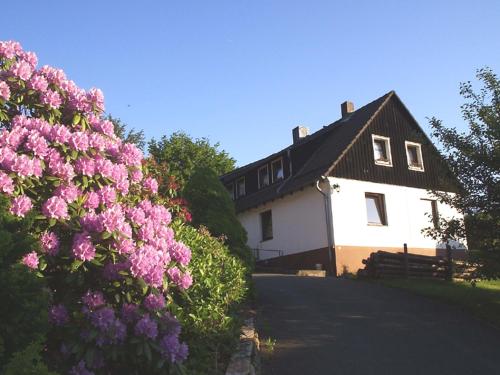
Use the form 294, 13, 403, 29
149, 131, 235, 186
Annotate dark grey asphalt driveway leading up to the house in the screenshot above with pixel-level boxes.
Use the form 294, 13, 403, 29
254, 274, 500, 375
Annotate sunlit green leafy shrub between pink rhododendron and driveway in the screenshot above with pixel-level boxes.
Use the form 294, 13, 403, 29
175, 224, 247, 374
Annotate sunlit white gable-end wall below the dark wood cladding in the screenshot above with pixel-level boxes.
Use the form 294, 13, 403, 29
329, 178, 463, 248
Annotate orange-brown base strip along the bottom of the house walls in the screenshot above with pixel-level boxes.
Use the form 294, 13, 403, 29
257, 245, 467, 275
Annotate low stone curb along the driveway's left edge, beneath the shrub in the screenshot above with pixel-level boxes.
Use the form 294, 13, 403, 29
226, 318, 260, 375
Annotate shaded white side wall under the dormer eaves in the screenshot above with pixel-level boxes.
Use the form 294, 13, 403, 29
238, 187, 328, 259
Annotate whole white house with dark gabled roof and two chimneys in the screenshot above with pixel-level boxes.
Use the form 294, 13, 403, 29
221, 91, 465, 274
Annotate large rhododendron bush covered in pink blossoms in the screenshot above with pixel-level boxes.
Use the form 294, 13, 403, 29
0, 42, 192, 374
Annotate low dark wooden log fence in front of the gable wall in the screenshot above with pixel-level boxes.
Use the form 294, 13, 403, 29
359, 244, 453, 280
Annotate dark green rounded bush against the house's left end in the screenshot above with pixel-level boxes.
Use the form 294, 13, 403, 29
184, 168, 251, 264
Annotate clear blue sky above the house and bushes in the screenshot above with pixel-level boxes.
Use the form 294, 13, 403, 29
0, 0, 500, 165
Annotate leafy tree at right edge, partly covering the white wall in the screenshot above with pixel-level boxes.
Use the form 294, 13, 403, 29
429, 68, 500, 277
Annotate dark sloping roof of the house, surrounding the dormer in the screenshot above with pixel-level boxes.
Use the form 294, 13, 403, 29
226, 91, 394, 212
